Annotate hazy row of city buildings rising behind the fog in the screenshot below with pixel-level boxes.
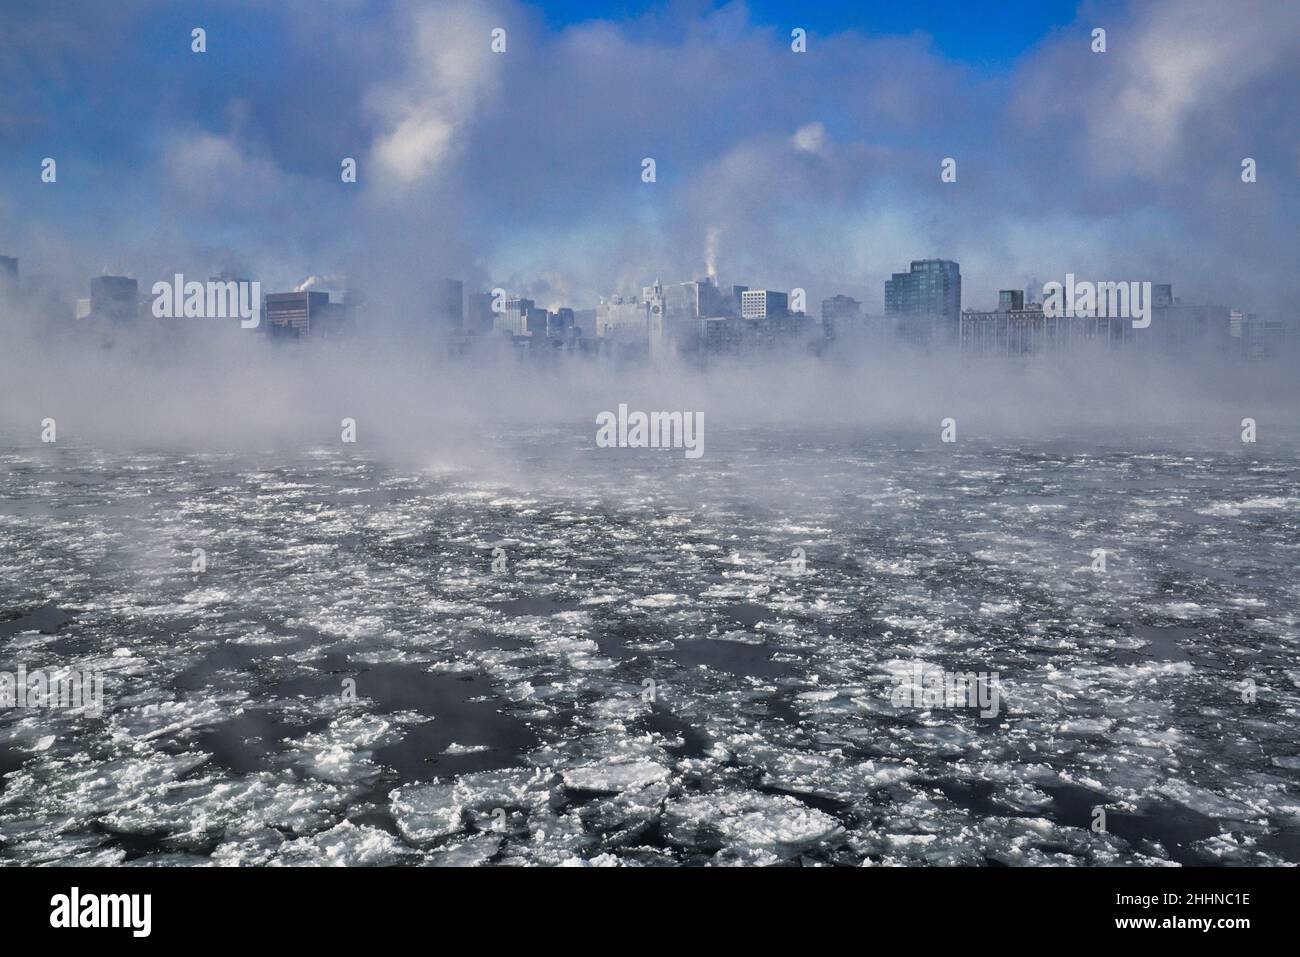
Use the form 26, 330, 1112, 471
0, 243, 1300, 364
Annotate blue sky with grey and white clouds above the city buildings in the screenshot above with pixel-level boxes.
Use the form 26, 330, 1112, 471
0, 0, 1300, 321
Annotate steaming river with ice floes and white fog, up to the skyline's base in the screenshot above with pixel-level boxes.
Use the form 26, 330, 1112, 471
0, 347, 1300, 865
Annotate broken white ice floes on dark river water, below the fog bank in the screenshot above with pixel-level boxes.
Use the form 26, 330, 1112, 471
0, 442, 1300, 866
